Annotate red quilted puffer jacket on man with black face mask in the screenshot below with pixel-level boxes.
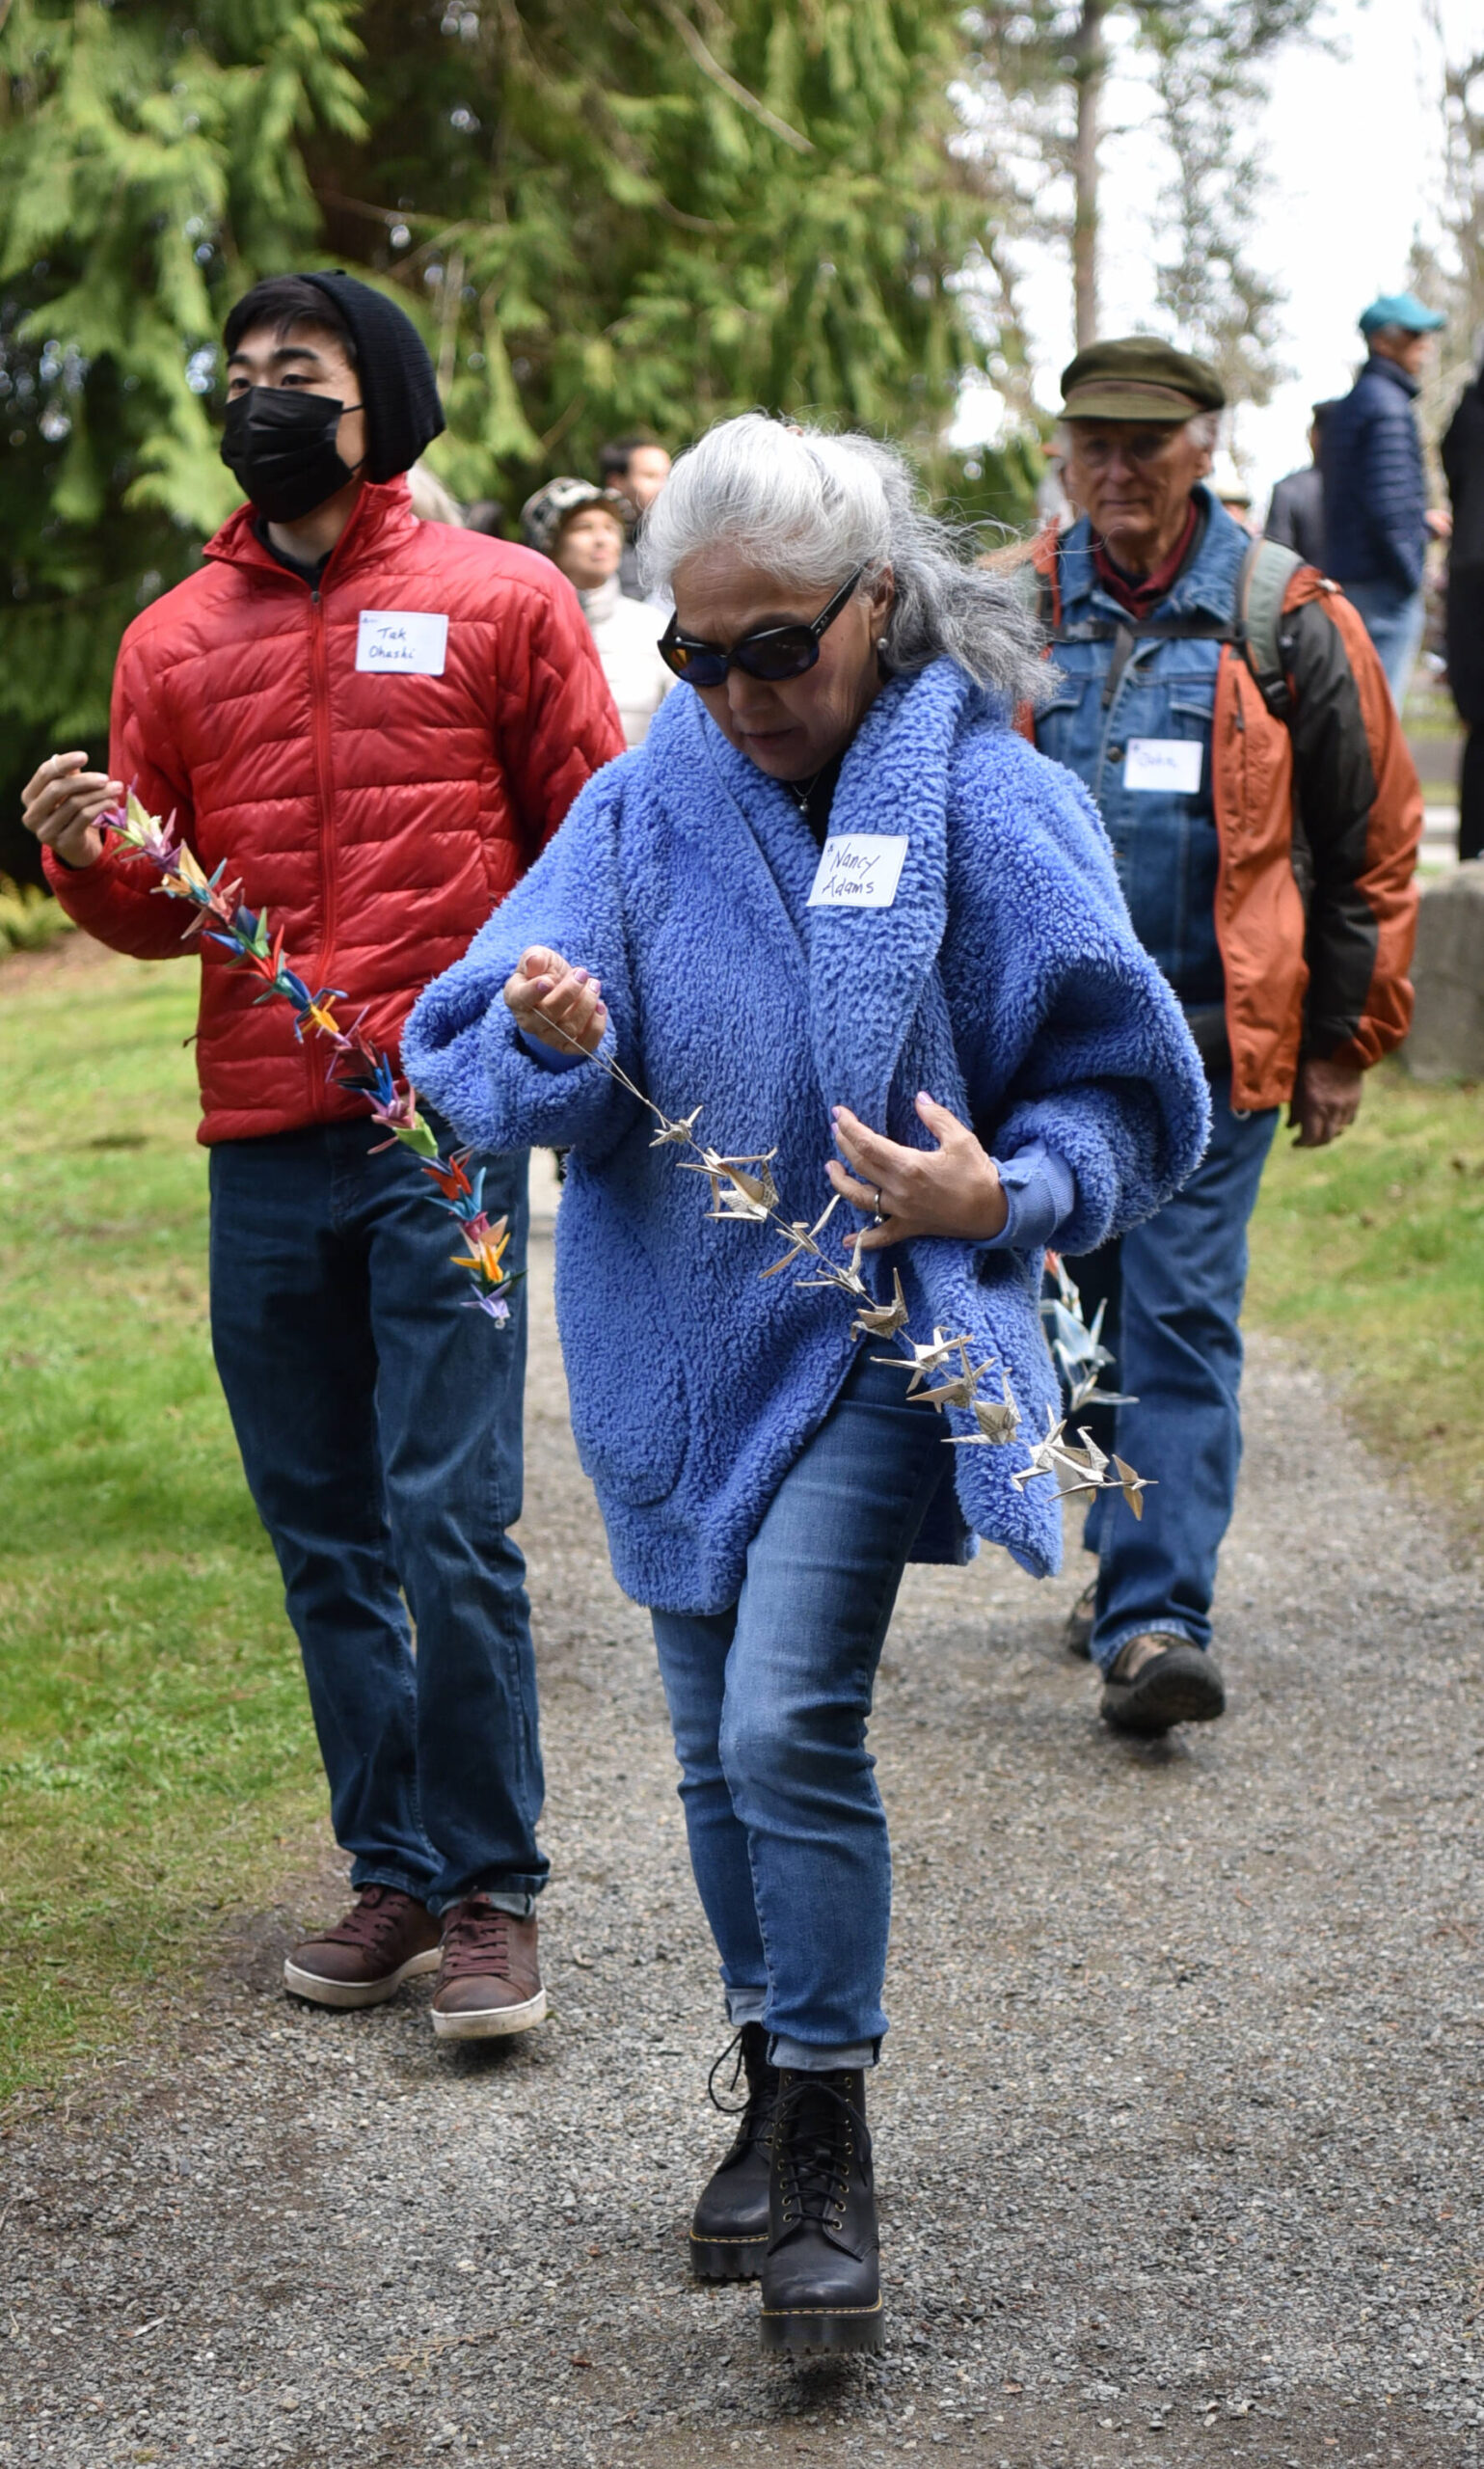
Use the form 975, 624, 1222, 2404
47, 479, 625, 1141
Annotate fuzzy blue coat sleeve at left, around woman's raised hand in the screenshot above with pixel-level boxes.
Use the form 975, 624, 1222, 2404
402, 773, 637, 1158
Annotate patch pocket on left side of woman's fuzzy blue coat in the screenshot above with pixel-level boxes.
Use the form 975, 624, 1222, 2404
555, 1158, 688, 1508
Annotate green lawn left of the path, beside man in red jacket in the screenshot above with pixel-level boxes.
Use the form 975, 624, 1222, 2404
0, 951, 323, 2094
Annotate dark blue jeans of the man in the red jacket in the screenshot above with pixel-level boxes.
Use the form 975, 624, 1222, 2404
210, 1121, 546, 1911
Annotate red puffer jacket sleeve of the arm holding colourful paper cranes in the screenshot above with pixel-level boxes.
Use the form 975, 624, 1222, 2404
42, 627, 200, 961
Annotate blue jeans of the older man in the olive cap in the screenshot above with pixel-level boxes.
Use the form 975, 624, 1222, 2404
1066, 1074, 1277, 1671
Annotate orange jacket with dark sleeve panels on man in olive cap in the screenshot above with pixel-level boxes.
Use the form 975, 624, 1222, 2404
1032, 530, 1422, 1111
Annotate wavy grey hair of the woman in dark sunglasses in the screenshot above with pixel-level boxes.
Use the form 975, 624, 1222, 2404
639, 413, 1049, 704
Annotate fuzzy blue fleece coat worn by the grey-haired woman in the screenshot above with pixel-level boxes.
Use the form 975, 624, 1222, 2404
402, 660, 1207, 1613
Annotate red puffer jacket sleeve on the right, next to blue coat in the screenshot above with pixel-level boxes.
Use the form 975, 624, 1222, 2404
497, 565, 625, 869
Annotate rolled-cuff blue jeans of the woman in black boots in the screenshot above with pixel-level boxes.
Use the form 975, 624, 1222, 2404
652, 1353, 946, 2069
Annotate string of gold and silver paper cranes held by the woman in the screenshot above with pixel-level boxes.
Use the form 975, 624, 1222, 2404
548, 1022, 1150, 1518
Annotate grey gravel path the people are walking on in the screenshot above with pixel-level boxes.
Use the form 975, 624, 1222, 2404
0, 1175, 1484, 2469
